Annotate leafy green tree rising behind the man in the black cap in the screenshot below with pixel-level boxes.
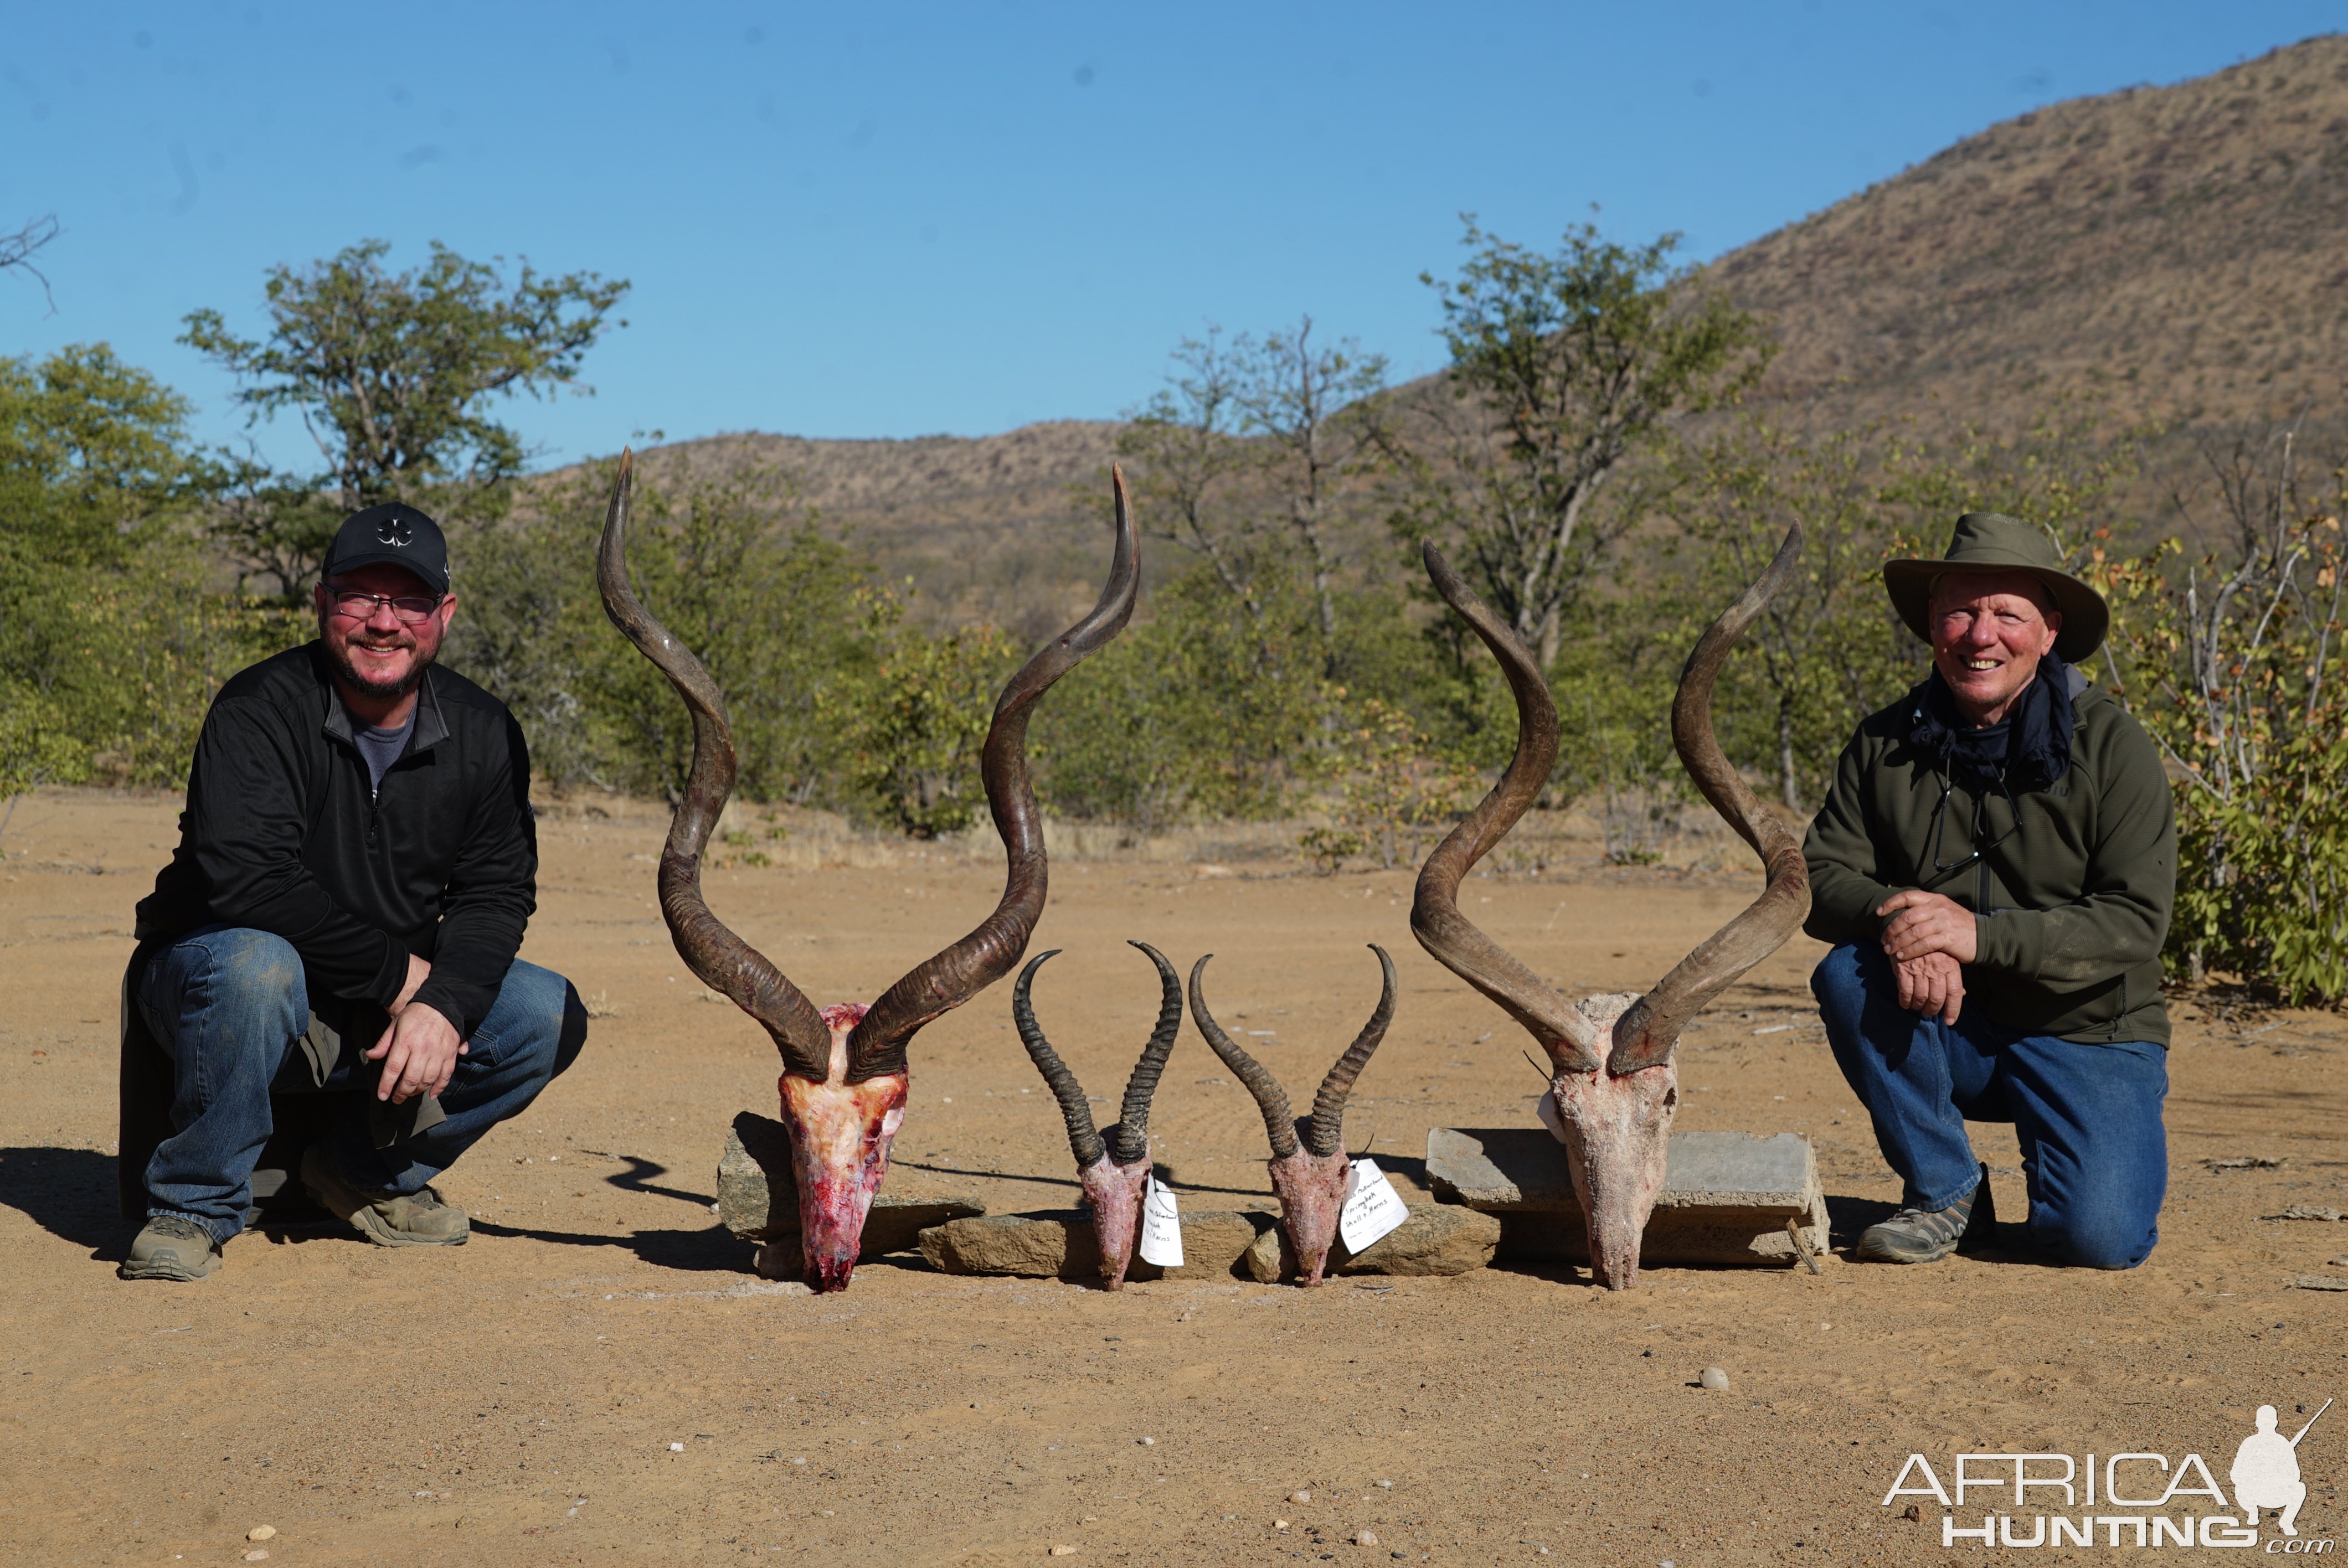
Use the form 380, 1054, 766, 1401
181, 239, 627, 596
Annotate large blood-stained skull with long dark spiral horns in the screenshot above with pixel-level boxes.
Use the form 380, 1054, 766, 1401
596, 453, 1141, 1291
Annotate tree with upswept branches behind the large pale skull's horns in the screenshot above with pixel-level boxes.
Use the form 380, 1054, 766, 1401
1383, 218, 1773, 667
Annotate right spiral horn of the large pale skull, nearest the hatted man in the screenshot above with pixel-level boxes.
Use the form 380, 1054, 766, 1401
1606, 523, 1810, 1075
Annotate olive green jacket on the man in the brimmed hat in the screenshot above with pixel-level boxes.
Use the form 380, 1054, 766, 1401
1803, 685, 2176, 1045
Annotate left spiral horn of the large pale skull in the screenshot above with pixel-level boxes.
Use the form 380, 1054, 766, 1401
1411, 540, 1599, 1072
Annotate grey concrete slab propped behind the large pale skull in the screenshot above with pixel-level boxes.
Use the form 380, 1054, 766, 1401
1428, 1127, 1834, 1265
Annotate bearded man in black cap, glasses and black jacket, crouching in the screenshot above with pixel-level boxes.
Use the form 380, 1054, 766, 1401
120, 502, 587, 1280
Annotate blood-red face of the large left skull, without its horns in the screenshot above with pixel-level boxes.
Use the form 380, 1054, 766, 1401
777, 1007, 909, 1291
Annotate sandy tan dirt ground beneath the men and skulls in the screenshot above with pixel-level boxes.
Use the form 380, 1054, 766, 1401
0, 791, 2348, 1568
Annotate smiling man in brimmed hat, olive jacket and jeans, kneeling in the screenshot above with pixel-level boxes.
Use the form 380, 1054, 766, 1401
1803, 512, 2176, 1267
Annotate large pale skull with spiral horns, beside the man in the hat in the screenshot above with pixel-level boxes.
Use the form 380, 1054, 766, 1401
1411, 523, 1810, 1291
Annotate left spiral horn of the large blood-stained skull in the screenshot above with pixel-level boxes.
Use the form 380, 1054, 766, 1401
596, 451, 831, 1080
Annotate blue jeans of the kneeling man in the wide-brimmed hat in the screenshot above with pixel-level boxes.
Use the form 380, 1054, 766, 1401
1810, 943, 2170, 1267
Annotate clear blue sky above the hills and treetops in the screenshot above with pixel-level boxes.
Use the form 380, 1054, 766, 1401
0, 0, 2339, 465
